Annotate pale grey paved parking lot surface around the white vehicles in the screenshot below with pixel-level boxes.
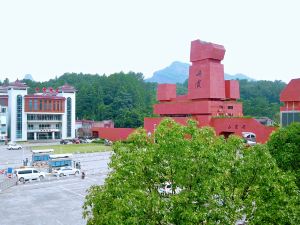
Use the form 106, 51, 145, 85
0, 142, 111, 225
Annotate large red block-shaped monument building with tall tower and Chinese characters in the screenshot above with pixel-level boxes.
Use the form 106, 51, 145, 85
95, 40, 274, 143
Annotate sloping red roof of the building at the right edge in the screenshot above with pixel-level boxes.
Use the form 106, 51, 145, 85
280, 78, 300, 102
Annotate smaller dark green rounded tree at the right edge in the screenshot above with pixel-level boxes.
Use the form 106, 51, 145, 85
268, 123, 300, 187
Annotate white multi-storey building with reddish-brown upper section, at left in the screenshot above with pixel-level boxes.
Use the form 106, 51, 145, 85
0, 80, 76, 142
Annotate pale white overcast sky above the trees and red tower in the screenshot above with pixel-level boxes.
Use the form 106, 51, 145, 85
0, 0, 300, 82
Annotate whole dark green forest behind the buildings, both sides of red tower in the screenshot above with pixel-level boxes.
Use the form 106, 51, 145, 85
3, 72, 286, 127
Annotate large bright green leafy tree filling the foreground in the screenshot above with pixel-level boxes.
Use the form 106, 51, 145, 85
83, 119, 300, 224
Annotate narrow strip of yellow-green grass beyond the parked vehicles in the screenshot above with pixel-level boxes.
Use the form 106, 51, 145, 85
32, 143, 112, 154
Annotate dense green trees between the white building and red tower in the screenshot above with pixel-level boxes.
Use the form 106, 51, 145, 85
24, 72, 156, 127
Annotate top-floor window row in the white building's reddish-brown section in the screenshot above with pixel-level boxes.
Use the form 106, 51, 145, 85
28, 99, 63, 111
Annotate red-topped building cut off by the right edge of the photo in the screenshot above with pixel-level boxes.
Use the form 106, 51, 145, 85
280, 78, 300, 127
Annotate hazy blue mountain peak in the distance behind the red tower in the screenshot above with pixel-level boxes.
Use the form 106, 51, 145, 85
145, 61, 254, 84
